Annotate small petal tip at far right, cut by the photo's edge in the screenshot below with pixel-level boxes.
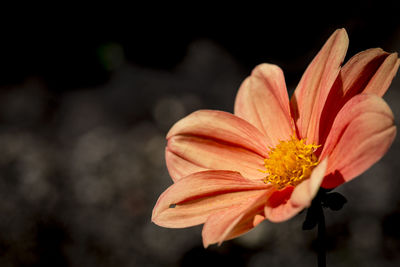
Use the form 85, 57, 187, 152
364, 53, 400, 96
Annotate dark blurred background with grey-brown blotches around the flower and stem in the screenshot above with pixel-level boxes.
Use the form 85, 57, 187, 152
0, 1, 400, 267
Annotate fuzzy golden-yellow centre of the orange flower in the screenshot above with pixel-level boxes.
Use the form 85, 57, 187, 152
263, 134, 320, 189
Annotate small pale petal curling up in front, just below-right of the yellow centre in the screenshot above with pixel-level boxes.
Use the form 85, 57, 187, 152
291, 158, 328, 208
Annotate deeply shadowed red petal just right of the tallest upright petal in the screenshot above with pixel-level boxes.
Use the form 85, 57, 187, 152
319, 48, 389, 148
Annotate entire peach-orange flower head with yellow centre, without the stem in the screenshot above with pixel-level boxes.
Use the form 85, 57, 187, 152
152, 29, 400, 247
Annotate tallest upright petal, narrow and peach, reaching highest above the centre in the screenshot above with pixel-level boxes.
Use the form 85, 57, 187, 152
290, 29, 349, 143
